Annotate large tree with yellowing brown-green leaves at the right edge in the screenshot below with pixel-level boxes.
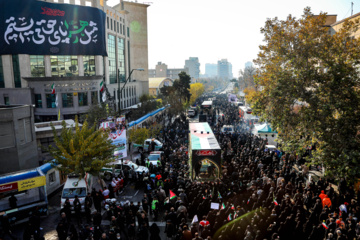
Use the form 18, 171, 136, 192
247, 8, 360, 181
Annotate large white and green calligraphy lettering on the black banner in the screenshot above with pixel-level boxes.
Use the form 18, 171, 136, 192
4, 17, 99, 45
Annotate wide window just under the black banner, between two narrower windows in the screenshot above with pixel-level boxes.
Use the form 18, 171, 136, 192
50, 56, 79, 77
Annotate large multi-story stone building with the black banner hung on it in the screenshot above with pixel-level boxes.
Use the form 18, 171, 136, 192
0, 0, 149, 121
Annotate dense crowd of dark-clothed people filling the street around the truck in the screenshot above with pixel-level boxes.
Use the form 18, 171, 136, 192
52, 94, 360, 240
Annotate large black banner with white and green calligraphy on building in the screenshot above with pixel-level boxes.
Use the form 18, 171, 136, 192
0, 0, 107, 56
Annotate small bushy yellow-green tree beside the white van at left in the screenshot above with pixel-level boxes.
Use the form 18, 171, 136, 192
47, 118, 115, 178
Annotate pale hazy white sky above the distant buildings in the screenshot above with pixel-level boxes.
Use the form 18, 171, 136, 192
107, 0, 360, 77
